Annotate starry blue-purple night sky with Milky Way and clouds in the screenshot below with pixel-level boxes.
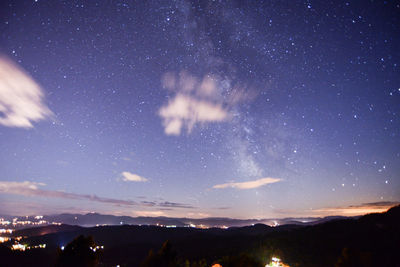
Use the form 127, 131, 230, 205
0, 0, 400, 218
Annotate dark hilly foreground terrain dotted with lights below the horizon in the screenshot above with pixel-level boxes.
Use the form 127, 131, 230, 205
0, 206, 400, 267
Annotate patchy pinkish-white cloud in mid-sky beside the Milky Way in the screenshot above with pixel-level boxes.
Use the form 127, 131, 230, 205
158, 71, 241, 135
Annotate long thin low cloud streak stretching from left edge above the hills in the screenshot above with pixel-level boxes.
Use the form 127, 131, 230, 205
0, 181, 194, 208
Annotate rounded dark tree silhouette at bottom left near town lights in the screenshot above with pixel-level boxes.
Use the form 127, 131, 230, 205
57, 235, 99, 267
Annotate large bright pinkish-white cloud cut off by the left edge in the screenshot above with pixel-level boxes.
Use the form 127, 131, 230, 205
0, 56, 53, 128
